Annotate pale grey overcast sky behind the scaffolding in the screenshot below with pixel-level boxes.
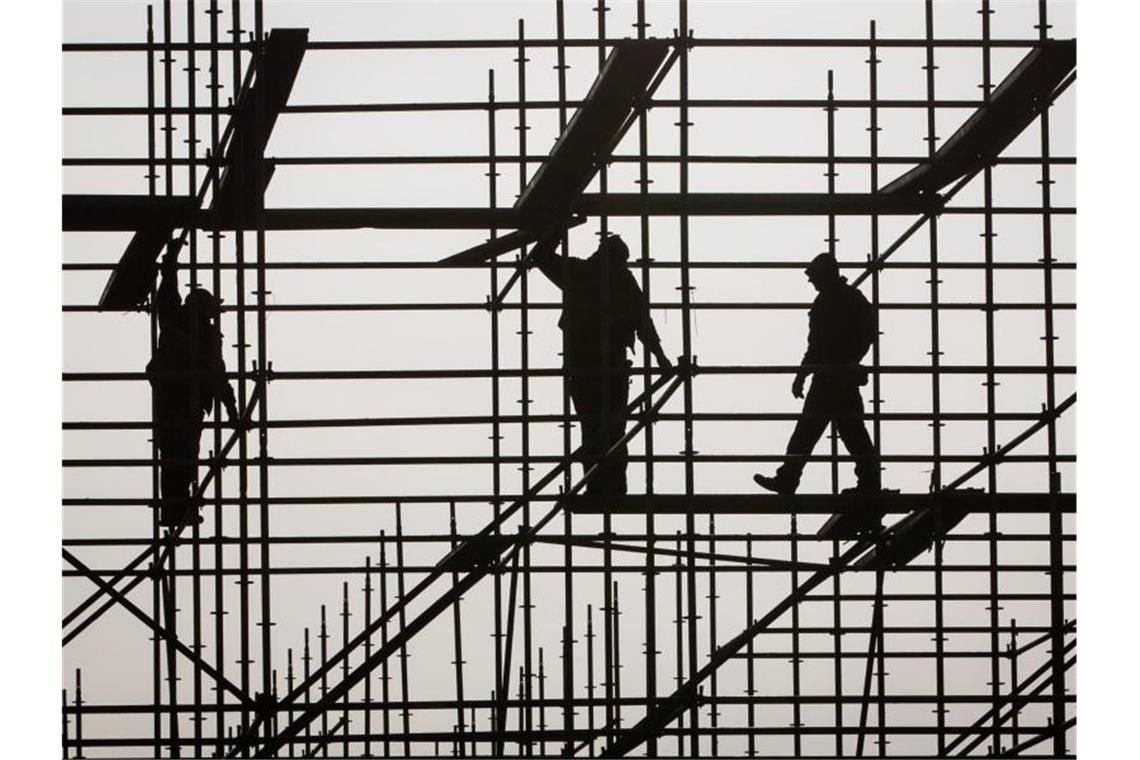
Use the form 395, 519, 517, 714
63, 2, 1077, 752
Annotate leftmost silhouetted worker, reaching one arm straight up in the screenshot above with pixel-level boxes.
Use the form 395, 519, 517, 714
146, 252, 239, 528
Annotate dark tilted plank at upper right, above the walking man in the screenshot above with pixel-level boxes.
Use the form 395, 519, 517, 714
882, 40, 1076, 194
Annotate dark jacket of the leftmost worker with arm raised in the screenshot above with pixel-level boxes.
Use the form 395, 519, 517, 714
146, 271, 234, 419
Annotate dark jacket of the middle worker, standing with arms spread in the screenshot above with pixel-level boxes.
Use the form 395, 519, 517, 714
536, 254, 660, 368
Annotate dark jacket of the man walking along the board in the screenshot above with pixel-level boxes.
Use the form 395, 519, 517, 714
801, 277, 878, 384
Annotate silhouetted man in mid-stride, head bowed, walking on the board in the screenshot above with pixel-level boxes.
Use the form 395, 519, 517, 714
752, 253, 881, 493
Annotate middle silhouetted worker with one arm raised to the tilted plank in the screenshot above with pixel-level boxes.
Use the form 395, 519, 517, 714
531, 231, 673, 496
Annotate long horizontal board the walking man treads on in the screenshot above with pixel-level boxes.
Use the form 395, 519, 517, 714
563, 490, 1076, 515
